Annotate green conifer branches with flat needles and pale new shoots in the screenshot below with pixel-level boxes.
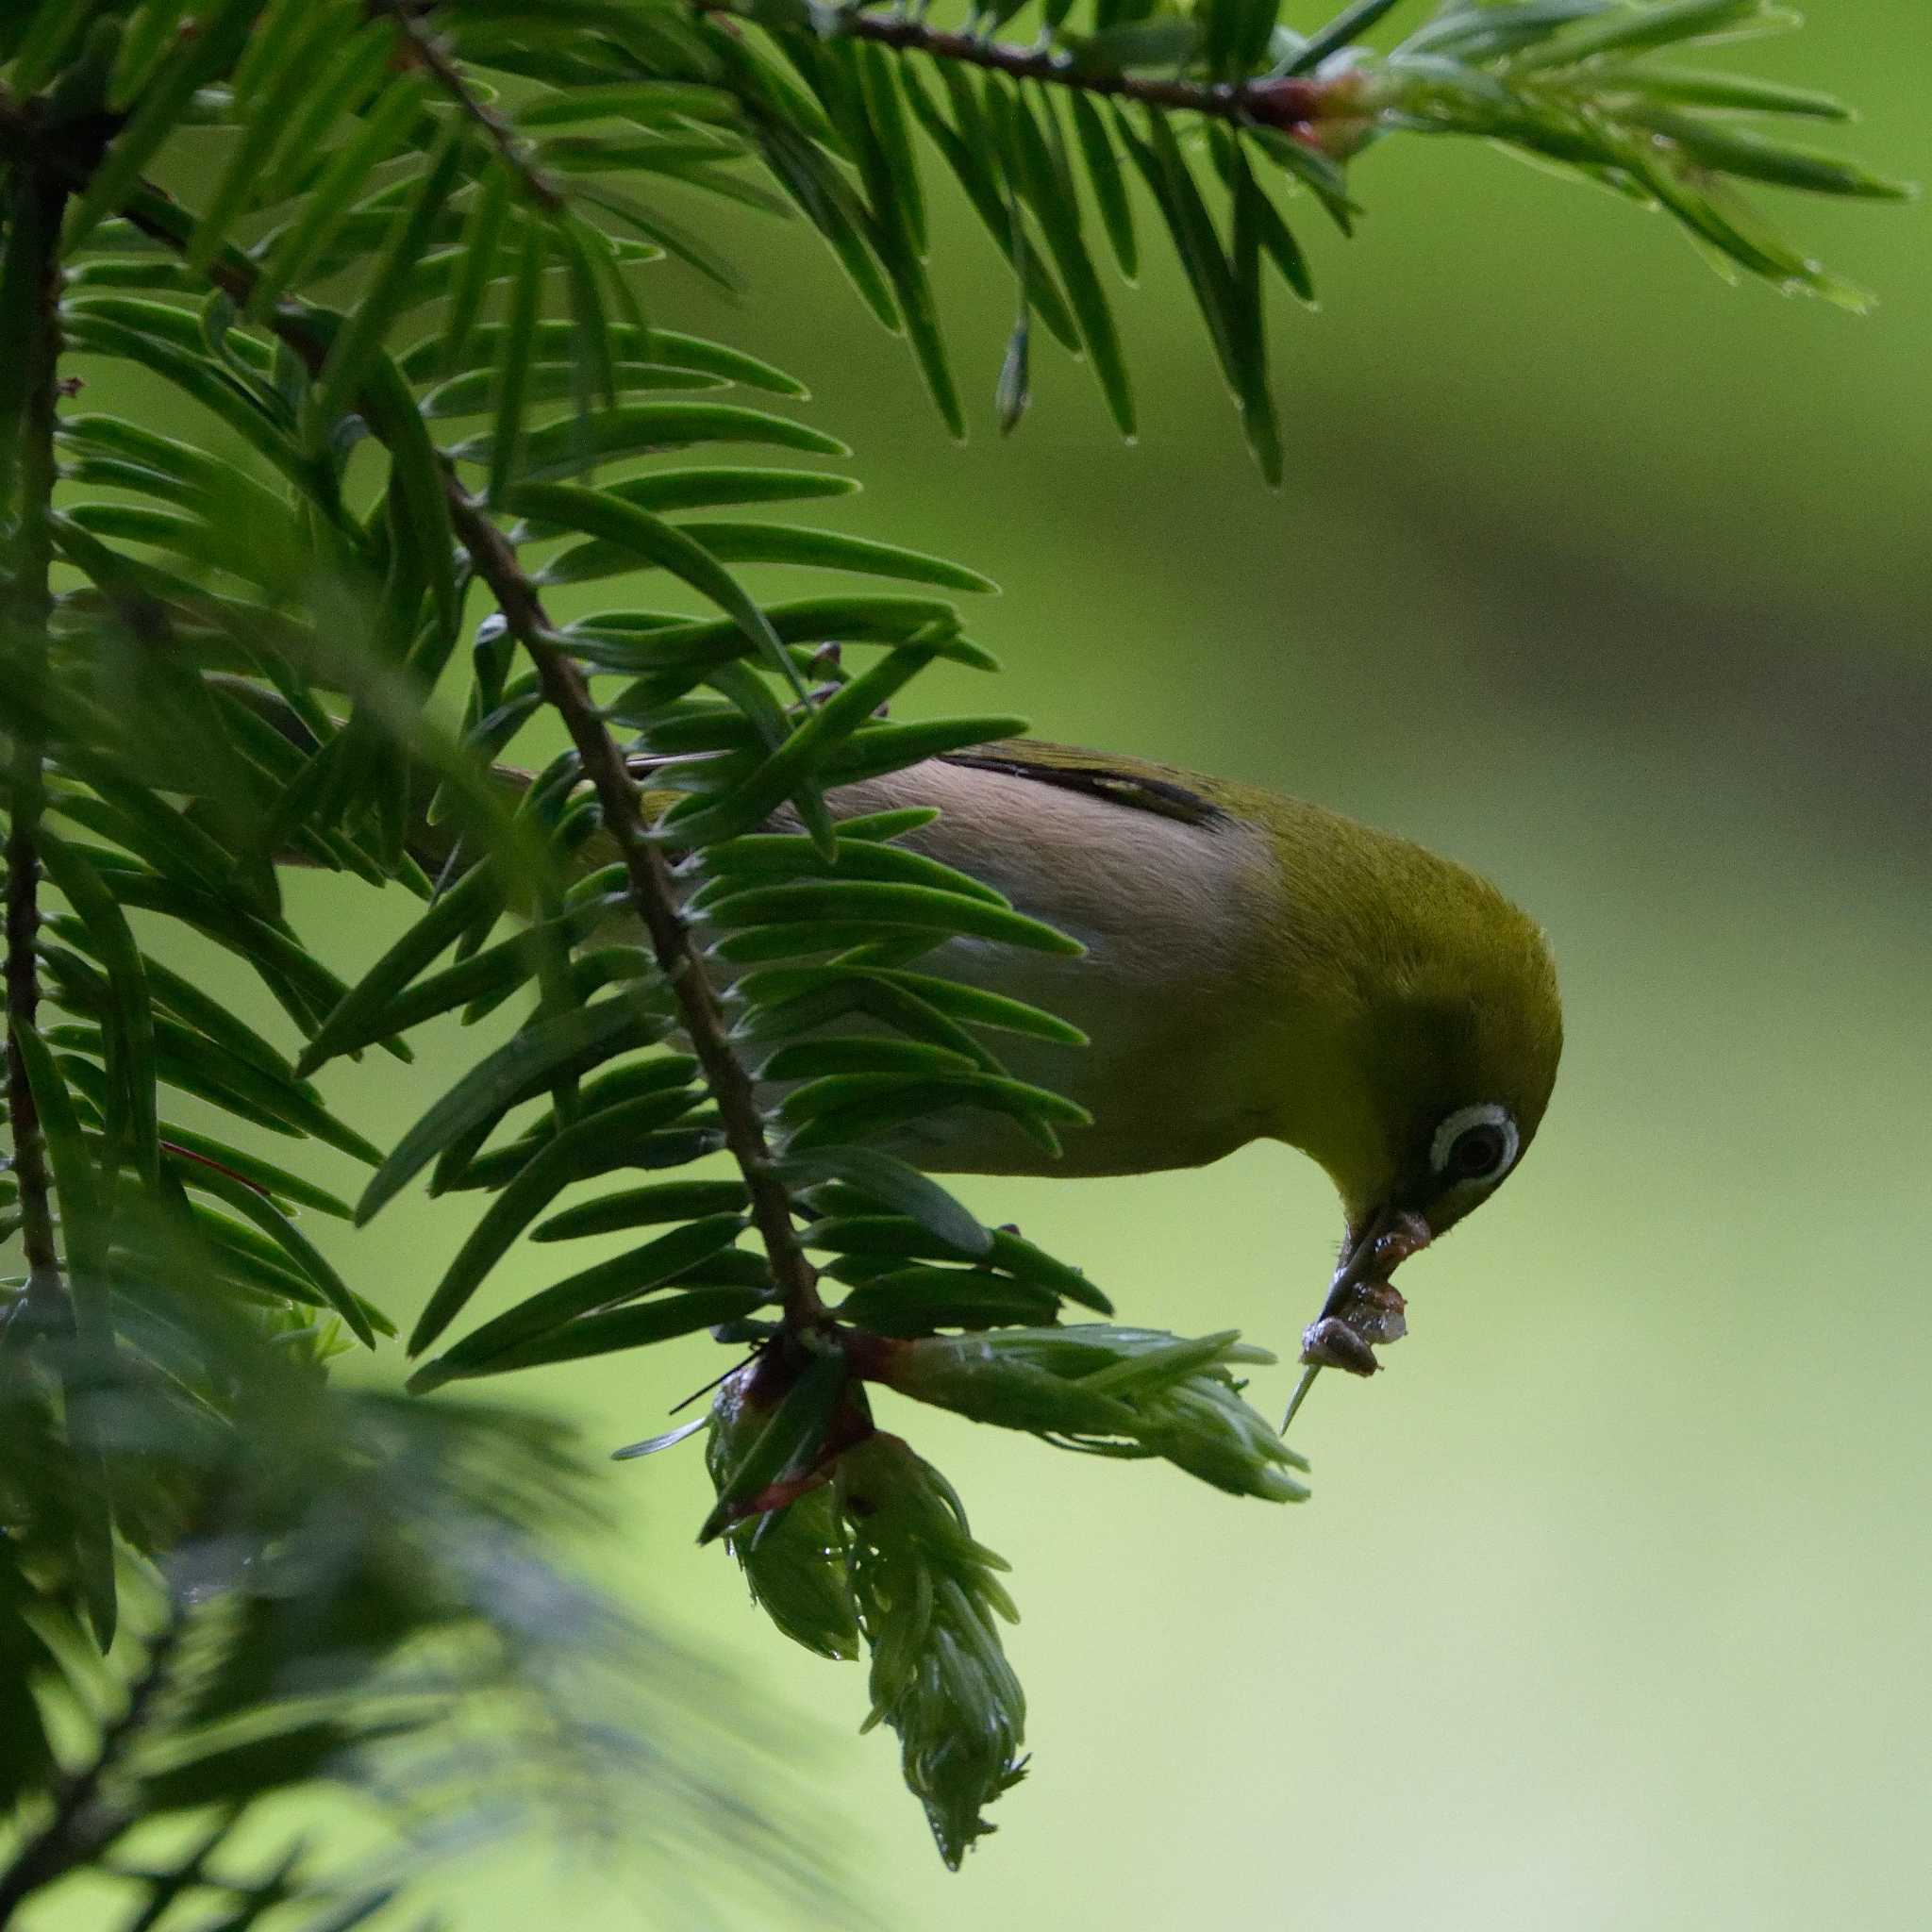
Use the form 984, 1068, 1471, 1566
0, 0, 1895, 1908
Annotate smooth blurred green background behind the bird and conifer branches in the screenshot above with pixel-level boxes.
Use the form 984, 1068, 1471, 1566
45, 0, 1932, 1932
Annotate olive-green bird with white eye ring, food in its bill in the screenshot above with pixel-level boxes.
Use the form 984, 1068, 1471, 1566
788, 738, 1563, 1391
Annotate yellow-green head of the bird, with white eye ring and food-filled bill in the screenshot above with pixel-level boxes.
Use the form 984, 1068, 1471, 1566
1285, 823, 1563, 1374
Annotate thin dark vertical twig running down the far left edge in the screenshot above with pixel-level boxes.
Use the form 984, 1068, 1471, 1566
4, 166, 68, 1325
